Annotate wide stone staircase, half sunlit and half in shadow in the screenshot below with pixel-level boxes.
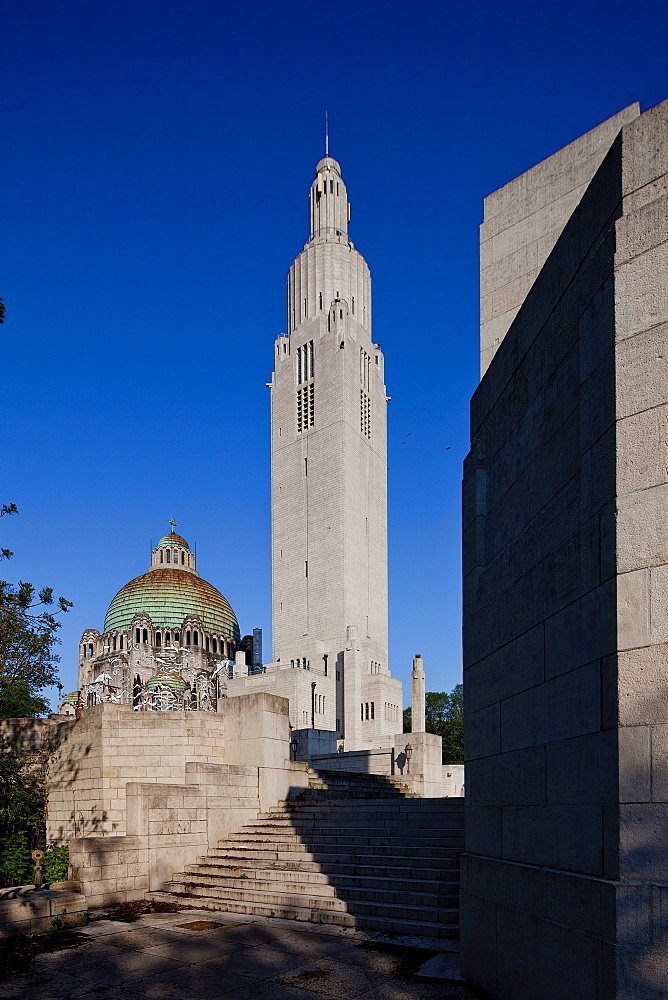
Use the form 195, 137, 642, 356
156, 771, 464, 938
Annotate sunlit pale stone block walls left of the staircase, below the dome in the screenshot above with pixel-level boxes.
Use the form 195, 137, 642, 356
47, 692, 309, 906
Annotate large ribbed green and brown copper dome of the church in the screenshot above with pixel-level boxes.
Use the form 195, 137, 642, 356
104, 568, 240, 640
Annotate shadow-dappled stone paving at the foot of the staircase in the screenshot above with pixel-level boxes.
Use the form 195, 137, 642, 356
0, 910, 482, 1000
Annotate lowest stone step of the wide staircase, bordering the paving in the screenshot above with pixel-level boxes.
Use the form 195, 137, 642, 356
151, 892, 459, 940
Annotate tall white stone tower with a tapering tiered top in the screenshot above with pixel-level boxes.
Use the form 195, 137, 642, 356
271, 156, 402, 748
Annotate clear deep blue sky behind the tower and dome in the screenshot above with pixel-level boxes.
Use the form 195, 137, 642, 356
0, 0, 668, 704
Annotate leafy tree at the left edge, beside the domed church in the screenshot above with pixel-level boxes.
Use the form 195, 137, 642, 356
0, 504, 72, 719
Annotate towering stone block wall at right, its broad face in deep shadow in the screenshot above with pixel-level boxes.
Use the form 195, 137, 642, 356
462, 103, 668, 1000
